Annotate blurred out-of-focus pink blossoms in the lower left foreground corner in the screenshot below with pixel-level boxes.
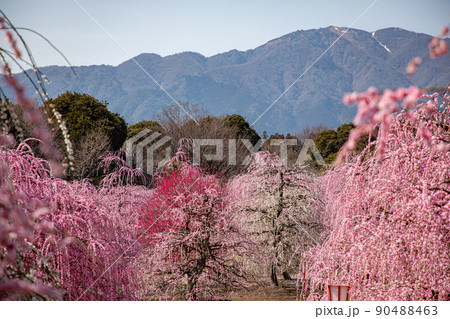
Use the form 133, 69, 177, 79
0, 142, 61, 300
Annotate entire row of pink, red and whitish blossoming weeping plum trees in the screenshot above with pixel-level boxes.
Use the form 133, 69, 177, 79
0, 11, 450, 300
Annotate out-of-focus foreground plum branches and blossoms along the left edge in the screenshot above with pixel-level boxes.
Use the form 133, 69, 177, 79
0, 10, 67, 300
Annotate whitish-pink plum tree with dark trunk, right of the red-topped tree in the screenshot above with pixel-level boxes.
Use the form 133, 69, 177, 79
228, 152, 322, 285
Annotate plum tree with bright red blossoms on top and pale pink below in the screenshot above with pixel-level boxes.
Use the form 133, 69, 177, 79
140, 152, 252, 300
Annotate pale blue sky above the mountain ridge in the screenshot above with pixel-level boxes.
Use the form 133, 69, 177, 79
0, 0, 450, 66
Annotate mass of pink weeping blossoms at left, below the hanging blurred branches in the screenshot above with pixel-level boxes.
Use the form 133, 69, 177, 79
0, 143, 148, 300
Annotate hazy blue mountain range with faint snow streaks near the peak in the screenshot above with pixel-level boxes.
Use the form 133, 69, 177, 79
10, 26, 450, 134
